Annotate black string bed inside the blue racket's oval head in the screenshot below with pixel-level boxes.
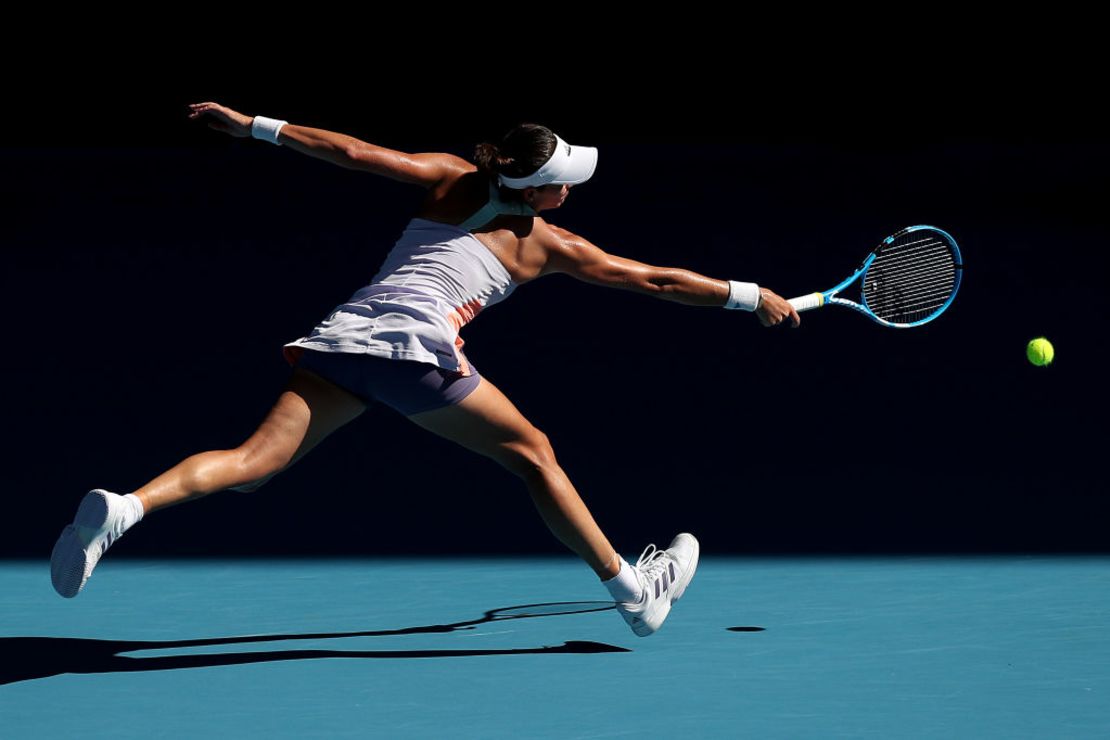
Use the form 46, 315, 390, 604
862, 230, 958, 324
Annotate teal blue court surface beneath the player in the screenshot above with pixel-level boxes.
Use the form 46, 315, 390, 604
0, 554, 1110, 738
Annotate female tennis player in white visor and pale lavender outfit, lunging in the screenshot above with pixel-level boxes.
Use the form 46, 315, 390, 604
51, 102, 799, 636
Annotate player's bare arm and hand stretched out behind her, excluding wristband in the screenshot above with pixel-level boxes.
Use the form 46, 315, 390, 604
189, 102, 466, 187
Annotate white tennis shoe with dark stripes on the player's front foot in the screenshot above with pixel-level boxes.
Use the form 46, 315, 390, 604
617, 533, 699, 637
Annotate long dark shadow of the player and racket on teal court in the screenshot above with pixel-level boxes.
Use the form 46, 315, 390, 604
0, 601, 630, 686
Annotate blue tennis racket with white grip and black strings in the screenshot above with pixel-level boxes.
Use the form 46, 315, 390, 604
790, 226, 963, 328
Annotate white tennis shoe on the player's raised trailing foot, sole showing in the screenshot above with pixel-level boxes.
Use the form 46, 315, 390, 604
50, 488, 128, 599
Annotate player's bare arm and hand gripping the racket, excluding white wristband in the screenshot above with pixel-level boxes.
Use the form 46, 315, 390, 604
543, 224, 800, 326
